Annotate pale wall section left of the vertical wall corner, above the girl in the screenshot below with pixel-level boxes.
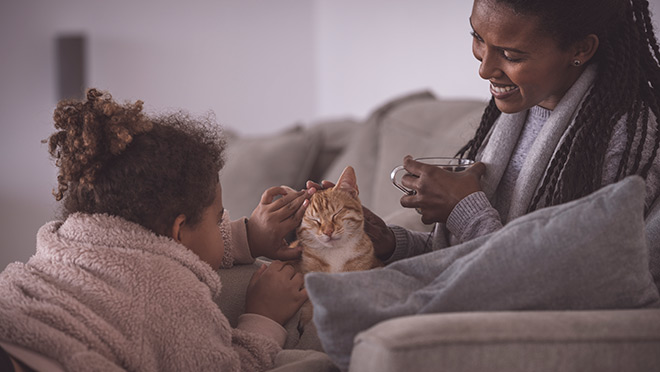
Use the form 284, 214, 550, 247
0, 0, 317, 269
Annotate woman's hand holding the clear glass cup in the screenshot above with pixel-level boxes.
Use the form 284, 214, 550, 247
401, 155, 486, 224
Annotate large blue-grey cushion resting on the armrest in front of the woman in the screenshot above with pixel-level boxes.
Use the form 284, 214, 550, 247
305, 176, 660, 370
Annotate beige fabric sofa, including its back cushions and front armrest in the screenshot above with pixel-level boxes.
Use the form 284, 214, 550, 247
219, 91, 660, 372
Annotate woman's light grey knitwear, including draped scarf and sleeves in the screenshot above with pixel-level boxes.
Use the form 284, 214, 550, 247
389, 66, 660, 288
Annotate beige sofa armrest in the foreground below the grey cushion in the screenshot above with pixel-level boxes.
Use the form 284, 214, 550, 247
350, 309, 660, 372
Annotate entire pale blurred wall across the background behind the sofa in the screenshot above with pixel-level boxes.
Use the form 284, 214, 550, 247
0, 0, 660, 270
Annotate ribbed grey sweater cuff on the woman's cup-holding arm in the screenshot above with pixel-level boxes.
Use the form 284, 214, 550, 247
447, 191, 502, 243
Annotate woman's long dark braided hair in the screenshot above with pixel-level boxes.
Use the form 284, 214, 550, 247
458, 0, 660, 211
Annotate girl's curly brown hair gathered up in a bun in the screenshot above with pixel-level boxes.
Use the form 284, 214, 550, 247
47, 89, 225, 234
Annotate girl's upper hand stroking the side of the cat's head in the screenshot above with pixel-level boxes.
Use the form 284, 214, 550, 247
247, 186, 313, 260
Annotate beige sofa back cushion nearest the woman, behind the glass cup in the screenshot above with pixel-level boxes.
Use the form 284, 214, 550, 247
324, 91, 486, 231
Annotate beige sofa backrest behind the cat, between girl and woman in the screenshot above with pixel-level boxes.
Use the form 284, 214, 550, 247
220, 91, 486, 231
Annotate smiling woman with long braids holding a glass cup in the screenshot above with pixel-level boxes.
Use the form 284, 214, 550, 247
354, 0, 660, 274
